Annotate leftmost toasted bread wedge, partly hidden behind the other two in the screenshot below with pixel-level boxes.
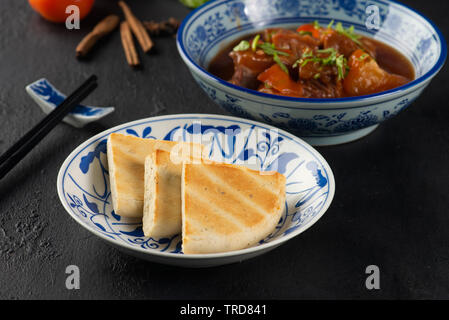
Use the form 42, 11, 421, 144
107, 133, 202, 218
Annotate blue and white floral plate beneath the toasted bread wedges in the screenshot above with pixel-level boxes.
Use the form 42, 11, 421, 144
57, 114, 335, 267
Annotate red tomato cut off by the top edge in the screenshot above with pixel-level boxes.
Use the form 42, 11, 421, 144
28, 0, 95, 22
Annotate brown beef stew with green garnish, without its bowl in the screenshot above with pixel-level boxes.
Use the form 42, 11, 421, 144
208, 21, 415, 99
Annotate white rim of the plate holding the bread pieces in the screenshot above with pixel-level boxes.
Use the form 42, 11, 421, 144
56, 113, 336, 260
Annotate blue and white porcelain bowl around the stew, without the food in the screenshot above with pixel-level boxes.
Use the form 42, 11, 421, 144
177, 0, 447, 145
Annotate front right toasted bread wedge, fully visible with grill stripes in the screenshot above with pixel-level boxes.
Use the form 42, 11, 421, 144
181, 163, 286, 254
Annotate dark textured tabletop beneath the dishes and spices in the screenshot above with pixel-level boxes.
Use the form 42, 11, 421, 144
0, 0, 449, 299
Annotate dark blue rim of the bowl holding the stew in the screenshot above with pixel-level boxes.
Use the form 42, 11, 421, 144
176, 0, 447, 104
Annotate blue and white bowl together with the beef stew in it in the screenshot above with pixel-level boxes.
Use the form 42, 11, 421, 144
177, 0, 447, 145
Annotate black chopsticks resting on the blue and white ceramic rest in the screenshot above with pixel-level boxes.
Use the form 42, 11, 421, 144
0, 75, 97, 179
